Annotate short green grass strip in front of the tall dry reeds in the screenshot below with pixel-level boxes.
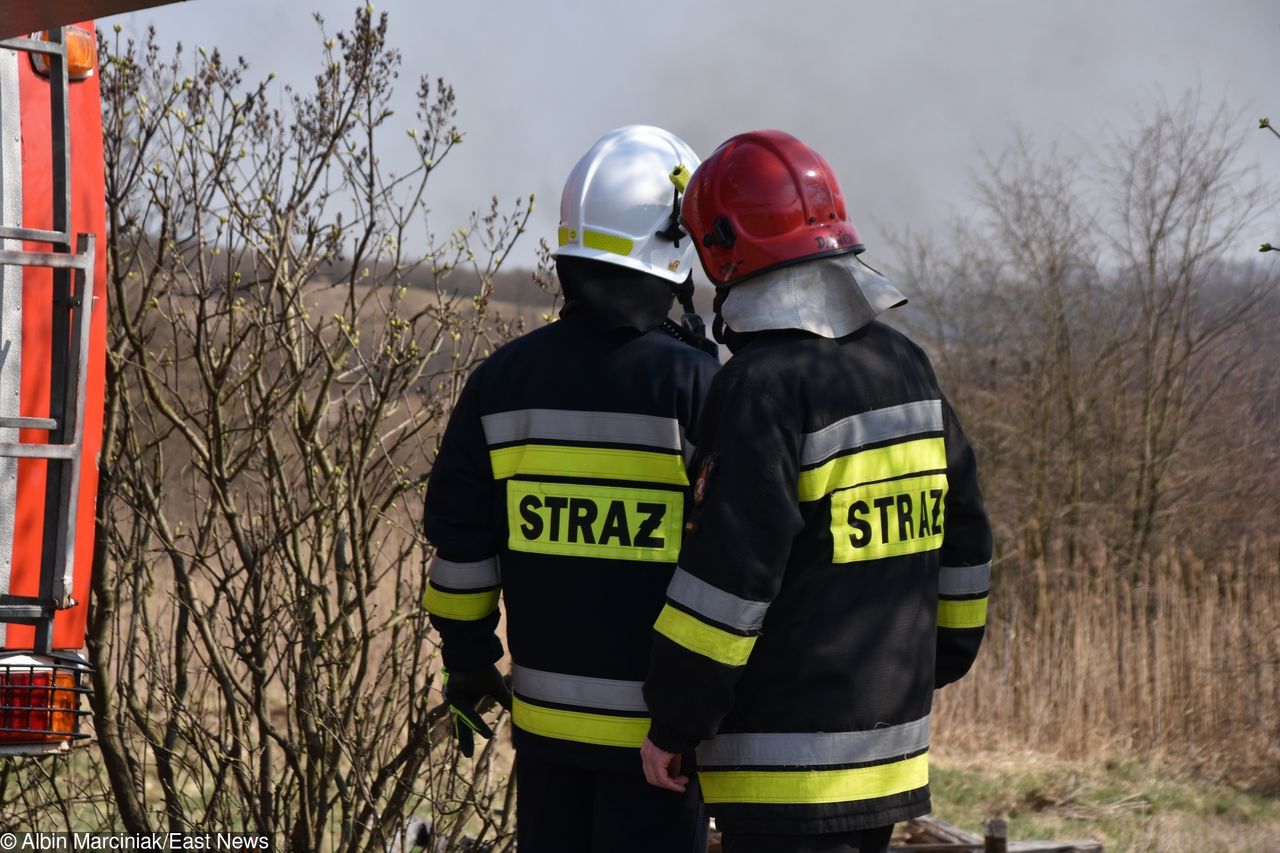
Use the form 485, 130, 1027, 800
932, 753, 1280, 853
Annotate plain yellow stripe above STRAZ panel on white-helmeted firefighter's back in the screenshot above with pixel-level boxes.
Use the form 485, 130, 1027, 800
489, 444, 689, 485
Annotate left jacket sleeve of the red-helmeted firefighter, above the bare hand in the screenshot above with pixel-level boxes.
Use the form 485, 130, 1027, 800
644, 368, 803, 752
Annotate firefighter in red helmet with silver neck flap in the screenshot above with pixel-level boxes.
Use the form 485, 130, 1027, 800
641, 131, 991, 853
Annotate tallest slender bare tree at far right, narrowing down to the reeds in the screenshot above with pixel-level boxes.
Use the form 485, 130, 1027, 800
1107, 96, 1274, 560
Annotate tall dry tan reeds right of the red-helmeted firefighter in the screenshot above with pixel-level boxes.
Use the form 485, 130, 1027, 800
936, 540, 1280, 793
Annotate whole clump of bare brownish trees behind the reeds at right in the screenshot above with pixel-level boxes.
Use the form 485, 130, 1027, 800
899, 97, 1275, 578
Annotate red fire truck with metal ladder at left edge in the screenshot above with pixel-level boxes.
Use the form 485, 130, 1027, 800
0, 0, 181, 756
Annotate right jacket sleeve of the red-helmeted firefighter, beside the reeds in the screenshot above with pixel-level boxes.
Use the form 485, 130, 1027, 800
934, 400, 991, 688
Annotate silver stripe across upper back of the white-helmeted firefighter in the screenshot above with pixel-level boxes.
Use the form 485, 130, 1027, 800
480, 409, 681, 452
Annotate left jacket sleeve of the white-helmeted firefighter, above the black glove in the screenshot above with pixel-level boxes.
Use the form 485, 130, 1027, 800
422, 368, 502, 672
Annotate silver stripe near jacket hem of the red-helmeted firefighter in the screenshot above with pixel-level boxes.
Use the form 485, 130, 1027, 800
698, 717, 929, 768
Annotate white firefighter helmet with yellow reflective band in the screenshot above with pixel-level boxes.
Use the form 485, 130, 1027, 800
554, 124, 699, 283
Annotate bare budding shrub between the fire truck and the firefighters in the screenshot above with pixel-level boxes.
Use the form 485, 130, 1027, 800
0, 6, 549, 850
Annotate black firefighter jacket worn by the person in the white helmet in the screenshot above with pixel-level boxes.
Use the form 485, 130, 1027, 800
424, 308, 718, 771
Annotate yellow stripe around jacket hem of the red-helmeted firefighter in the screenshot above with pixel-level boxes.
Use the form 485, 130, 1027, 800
698, 752, 929, 804
